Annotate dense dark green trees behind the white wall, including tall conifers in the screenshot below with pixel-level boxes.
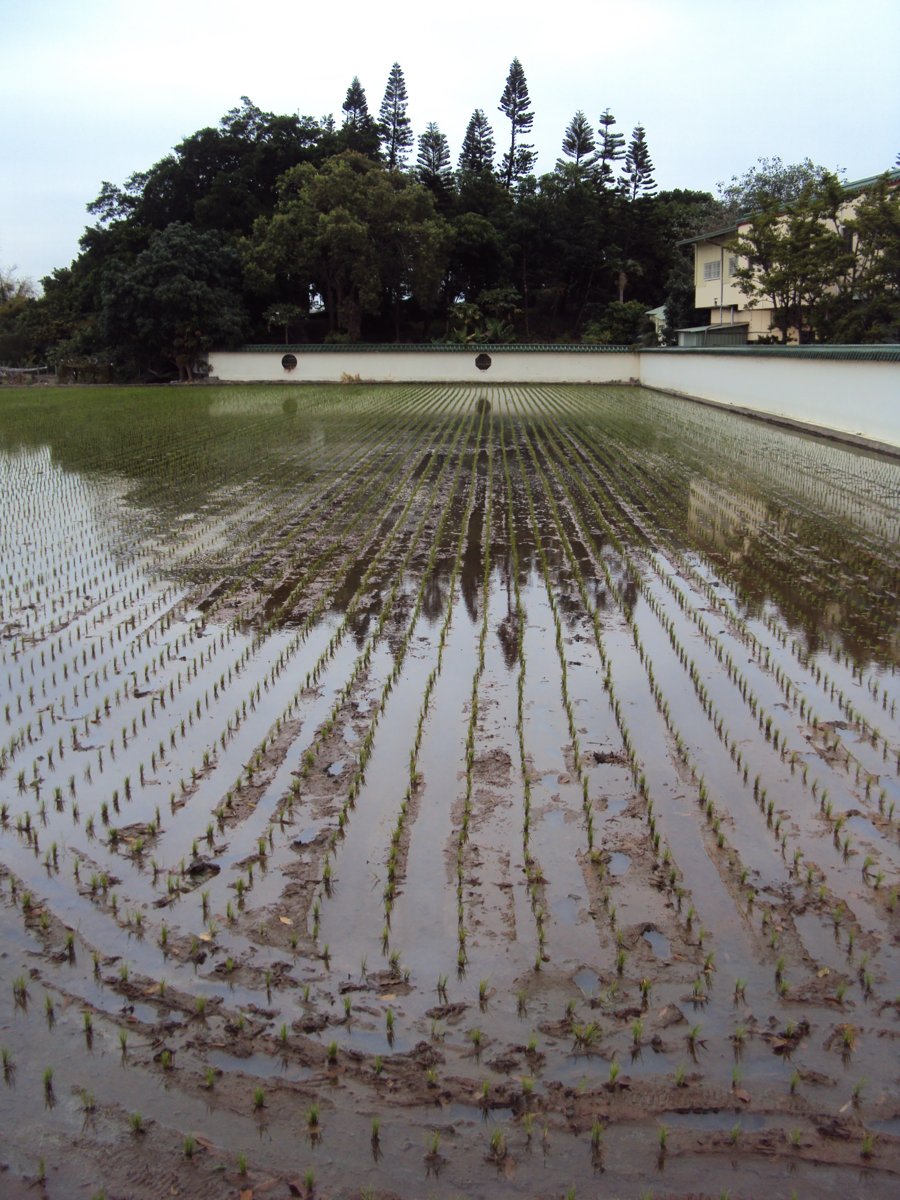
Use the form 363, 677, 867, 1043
0, 69, 900, 377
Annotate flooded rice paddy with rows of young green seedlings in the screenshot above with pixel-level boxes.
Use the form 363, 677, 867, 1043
0, 385, 900, 1198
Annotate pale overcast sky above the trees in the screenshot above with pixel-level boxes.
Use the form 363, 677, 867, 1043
0, 0, 900, 282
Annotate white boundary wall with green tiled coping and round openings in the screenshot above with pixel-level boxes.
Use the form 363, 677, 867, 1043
209, 347, 900, 449
